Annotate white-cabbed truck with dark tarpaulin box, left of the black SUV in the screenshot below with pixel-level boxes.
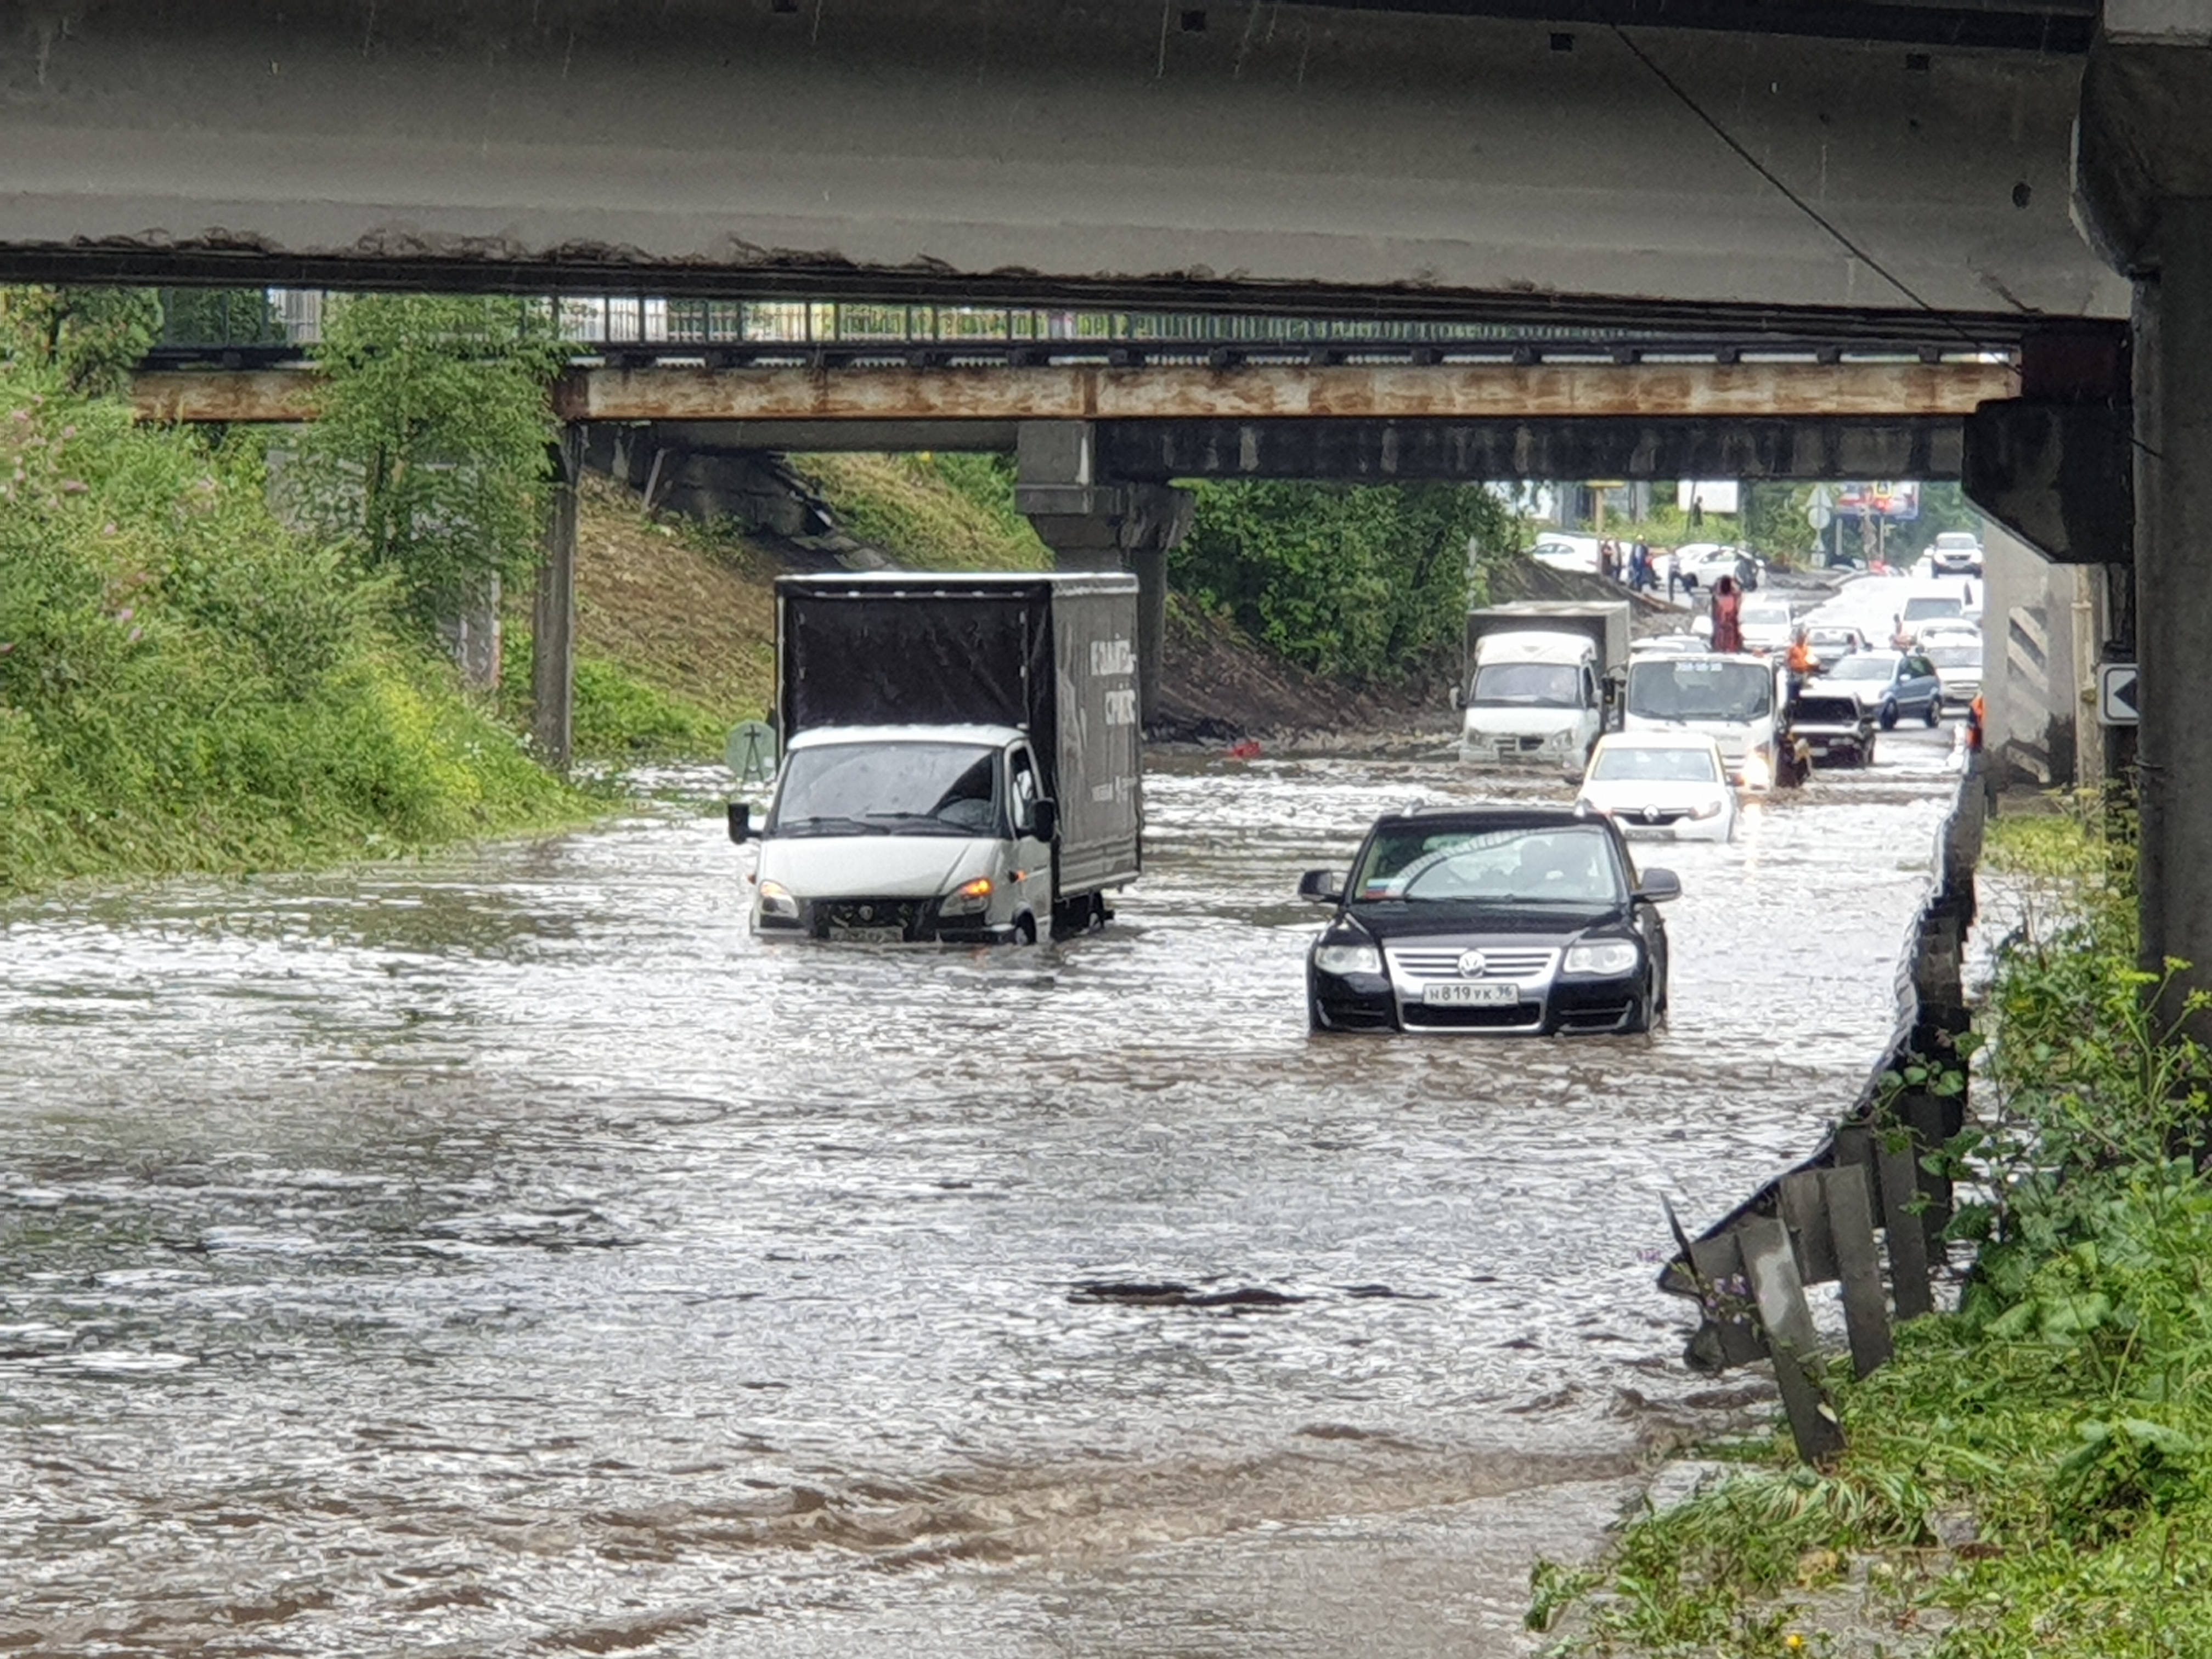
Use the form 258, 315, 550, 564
730, 571, 1144, 943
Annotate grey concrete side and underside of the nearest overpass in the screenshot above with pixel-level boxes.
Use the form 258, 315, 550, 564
0, 0, 2128, 338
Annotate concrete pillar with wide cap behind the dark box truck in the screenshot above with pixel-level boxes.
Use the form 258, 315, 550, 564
1013, 420, 1192, 721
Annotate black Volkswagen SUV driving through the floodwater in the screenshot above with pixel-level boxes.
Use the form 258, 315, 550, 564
1299, 808, 1681, 1035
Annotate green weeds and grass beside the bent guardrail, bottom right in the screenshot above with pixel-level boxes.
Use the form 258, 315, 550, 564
1531, 800, 2212, 1659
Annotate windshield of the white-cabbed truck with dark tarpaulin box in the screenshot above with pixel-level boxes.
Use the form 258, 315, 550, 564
768, 743, 1000, 836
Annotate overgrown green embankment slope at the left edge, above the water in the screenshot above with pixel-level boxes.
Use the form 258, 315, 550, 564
0, 360, 591, 896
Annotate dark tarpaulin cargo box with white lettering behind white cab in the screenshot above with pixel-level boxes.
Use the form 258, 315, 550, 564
776, 571, 1144, 898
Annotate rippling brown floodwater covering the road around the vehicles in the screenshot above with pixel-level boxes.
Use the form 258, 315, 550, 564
0, 735, 1951, 1659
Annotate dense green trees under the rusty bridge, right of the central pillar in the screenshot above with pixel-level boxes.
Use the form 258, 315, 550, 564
1168, 480, 1520, 681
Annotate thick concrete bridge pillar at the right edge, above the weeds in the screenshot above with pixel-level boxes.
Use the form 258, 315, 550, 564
2073, 29, 2212, 1040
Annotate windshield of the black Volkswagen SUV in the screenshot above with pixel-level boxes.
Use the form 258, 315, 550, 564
1352, 823, 1628, 905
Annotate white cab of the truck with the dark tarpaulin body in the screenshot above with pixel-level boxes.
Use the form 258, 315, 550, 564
752, 725, 1059, 945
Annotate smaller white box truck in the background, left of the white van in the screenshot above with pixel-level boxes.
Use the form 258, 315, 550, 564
1458, 600, 1628, 778
